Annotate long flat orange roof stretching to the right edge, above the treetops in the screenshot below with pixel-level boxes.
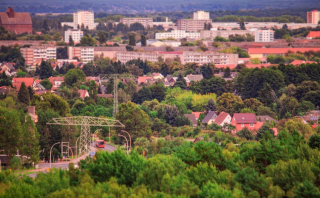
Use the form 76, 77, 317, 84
248, 48, 320, 54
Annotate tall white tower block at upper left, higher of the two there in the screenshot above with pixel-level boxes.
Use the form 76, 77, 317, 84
73, 11, 96, 30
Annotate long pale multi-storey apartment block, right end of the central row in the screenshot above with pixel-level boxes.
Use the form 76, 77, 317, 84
180, 51, 239, 65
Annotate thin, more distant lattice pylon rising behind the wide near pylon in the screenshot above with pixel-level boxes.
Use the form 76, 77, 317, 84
99, 73, 134, 118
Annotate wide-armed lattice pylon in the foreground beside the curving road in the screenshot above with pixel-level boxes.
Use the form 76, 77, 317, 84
47, 116, 125, 153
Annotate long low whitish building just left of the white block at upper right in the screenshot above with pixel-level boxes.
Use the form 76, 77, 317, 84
200, 30, 255, 39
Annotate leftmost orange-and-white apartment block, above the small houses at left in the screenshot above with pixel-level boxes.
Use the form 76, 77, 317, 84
20, 46, 57, 65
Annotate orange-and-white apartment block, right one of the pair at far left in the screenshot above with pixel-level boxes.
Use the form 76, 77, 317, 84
68, 47, 94, 63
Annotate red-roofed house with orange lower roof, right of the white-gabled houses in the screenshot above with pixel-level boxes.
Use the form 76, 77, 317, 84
231, 113, 263, 132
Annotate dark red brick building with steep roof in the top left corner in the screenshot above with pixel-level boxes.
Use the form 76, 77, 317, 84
0, 7, 32, 34
